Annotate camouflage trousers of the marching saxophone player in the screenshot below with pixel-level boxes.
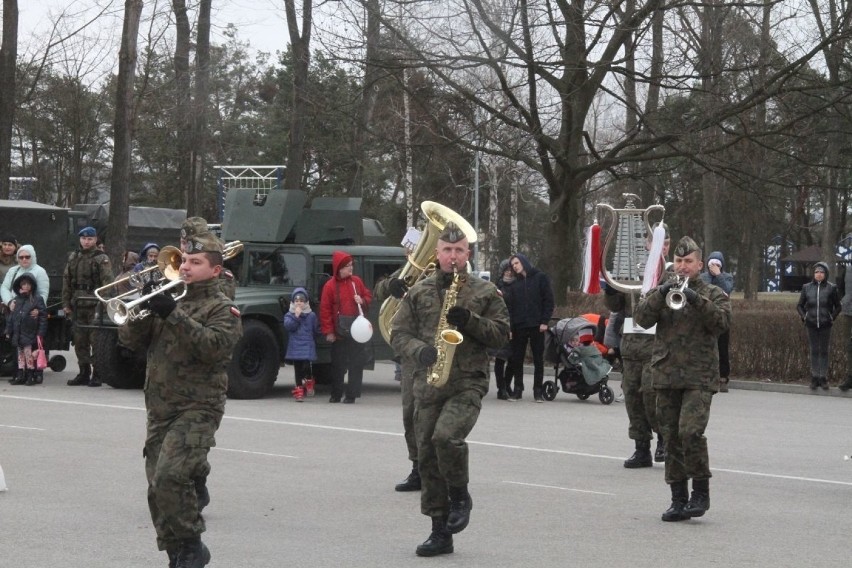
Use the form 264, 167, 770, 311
414, 385, 482, 517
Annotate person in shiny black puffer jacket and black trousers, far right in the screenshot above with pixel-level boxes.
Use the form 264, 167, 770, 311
796, 262, 840, 390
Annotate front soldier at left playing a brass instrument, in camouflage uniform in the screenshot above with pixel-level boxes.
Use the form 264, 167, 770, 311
119, 233, 242, 568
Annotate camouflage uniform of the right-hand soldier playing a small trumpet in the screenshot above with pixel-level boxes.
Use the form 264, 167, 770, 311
634, 268, 731, 484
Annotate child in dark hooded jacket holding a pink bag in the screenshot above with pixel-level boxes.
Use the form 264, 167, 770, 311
6, 273, 47, 385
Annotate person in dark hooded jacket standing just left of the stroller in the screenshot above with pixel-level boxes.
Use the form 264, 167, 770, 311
503, 254, 554, 402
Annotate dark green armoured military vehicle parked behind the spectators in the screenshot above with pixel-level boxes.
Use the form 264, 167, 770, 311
96, 190, 406, 399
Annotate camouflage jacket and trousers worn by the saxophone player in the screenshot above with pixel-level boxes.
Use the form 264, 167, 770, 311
391, 271, 509, 519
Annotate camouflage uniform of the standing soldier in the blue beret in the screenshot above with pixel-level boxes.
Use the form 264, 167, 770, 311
62, 247, 113, 370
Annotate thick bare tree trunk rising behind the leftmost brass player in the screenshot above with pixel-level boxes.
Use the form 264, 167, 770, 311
107, 0, 143, 266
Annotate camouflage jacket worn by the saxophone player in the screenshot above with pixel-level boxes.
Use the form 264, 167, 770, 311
391, 271, 509, 395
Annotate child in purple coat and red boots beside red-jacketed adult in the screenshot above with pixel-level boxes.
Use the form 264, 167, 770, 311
284, 288, 320, 402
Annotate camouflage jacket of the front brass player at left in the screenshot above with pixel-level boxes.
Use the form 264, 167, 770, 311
119, 279, 242, 420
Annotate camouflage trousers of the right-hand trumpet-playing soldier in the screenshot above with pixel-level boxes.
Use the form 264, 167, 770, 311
657, 389, 713, 484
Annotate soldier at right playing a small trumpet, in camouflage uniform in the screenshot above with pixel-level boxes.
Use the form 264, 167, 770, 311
633, 237, 731, 521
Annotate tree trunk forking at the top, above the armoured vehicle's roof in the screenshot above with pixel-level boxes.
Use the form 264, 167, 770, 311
284, 0, 312, 193
